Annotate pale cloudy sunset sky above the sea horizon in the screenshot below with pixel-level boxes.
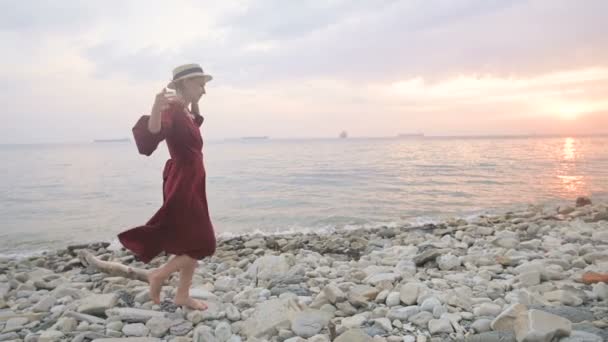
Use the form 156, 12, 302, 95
0, 0, 608, 143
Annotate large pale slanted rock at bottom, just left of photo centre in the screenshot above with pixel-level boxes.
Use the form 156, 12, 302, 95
242, 299, 302, 339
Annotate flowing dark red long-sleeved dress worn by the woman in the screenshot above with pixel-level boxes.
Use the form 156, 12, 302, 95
118, 103, 216, 263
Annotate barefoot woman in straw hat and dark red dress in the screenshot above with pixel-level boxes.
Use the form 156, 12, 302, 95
118, 64, 216, 310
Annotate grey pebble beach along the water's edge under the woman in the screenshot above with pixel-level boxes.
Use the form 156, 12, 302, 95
0, 198, 608, 342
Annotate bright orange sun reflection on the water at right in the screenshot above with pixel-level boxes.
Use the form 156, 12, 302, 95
557, 138, 589, 197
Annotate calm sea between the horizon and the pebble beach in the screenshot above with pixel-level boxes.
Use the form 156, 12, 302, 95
0, 136, 608, 257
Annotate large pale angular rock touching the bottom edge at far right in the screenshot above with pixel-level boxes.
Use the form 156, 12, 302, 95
514, 310, 572, 342
